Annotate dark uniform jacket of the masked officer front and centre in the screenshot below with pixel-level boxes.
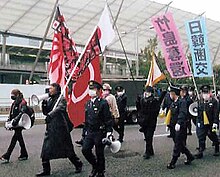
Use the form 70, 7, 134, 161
84, 98, 113, 133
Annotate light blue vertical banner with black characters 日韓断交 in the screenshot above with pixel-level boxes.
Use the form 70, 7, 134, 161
186, 18, 213, 77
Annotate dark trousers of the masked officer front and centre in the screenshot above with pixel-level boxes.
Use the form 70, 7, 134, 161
82, 131, 105, 172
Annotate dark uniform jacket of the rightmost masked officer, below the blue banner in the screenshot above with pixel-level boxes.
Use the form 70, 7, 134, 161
197, 98, 219, 126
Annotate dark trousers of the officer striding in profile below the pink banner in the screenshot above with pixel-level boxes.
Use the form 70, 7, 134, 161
173, 126, 192, 158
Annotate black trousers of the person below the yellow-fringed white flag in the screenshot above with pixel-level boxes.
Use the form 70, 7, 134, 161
143, 127, 155, 155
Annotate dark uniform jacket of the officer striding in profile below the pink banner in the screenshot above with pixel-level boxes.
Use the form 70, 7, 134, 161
170, 97, 188, 126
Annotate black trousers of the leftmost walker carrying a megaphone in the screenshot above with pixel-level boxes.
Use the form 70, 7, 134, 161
3, 128, 28, 160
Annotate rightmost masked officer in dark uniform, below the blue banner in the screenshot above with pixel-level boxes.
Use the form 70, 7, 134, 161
195, 85, 219, 159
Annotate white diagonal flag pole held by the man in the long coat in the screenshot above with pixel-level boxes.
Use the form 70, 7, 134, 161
53, 26, 97, 110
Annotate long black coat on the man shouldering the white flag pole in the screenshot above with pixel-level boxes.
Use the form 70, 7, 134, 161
41, 95, 74, 160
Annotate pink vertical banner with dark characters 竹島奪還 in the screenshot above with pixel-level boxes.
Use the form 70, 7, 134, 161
151, 13, 191, 78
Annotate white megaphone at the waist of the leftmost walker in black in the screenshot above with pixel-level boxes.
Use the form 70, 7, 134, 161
5, 113, 31, 130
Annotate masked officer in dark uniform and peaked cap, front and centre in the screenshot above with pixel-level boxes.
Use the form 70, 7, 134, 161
82, 81, 112, 177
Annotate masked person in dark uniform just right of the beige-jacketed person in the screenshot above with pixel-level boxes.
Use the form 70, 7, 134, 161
114, 86, 127, 143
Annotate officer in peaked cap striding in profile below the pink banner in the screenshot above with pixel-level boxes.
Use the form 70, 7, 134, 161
167, 86, 194, 169
